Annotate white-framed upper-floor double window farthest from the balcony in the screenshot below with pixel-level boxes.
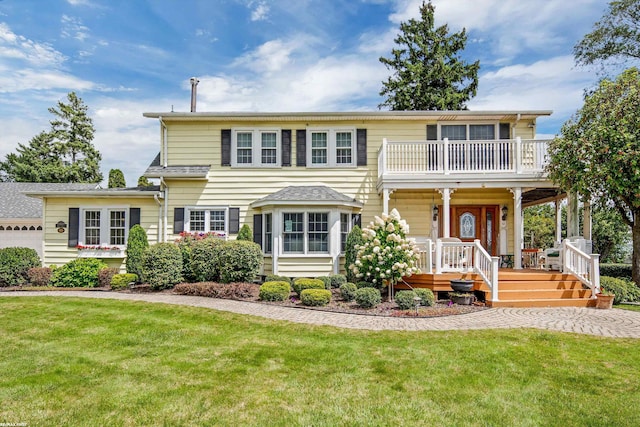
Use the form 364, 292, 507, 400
231, 129, 280, 167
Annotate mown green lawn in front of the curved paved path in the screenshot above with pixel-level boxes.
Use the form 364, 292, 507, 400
0, 297, 640, 427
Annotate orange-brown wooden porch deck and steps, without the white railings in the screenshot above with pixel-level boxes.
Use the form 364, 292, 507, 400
396, 268, 595, 307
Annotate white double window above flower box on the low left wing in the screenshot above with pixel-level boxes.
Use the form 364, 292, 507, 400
79, 208, 129, 246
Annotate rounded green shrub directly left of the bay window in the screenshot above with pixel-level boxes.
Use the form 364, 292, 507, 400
217, 240, 263, 283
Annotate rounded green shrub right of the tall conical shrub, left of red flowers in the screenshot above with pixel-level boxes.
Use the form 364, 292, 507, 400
142, 243, 182, 289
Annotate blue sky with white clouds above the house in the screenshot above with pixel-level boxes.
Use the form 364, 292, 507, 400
0, 0, 608, 186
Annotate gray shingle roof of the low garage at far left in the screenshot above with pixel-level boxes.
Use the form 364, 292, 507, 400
0, 182, 97, 219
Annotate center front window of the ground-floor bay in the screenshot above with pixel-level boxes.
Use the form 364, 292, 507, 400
282, 212, 329, 254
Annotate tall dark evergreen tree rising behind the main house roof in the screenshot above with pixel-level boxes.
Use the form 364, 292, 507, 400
378, 2, 480, 110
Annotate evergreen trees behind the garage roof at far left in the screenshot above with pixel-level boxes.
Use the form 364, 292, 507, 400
0, 92, 102, 182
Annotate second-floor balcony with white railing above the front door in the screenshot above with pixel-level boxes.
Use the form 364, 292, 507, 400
378, 138, 549, 188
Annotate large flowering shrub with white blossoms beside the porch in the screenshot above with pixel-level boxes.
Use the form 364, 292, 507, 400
349, 209, 420, 287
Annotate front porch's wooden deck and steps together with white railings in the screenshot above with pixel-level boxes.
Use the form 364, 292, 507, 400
396, 239, 600, 307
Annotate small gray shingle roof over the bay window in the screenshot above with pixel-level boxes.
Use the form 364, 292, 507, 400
252, 185, 362, 207
